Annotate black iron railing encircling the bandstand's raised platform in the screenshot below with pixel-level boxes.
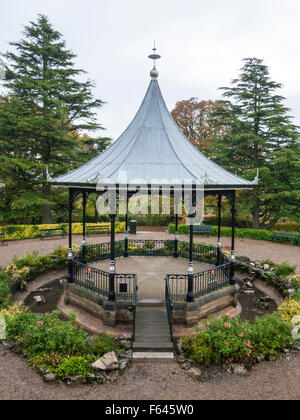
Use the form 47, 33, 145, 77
73, 240, 230, 304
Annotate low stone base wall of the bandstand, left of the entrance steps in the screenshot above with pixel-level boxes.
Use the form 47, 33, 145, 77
64, 283, 133, 327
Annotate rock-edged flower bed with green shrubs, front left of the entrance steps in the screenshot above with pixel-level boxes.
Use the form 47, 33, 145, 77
0, 304, 131, 383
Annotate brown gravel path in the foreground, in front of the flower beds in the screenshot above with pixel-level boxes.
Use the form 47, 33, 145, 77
0, 345, 300, 400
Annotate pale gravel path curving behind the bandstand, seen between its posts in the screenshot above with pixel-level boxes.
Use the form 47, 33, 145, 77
0, 232, 300, 275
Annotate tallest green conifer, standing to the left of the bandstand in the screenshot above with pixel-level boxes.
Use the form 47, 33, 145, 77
0, 15, 107, 223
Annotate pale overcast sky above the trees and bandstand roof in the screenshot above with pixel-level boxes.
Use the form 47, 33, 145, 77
0, 0, 300, 139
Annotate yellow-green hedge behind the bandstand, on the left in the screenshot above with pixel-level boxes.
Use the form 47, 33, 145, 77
0, 222, 125, 241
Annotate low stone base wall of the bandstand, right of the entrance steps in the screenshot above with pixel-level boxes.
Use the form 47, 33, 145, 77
173, 286, 238, 327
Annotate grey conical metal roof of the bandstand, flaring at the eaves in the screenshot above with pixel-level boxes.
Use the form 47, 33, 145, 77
52, 74, 253, 189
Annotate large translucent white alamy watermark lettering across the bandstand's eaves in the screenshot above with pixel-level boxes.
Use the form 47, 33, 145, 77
97, 171, 204, 224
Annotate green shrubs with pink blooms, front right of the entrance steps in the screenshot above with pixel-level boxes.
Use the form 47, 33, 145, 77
182, 312, 294, 365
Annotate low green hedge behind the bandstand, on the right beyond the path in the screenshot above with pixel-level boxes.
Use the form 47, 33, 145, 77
168, 223, 300, 246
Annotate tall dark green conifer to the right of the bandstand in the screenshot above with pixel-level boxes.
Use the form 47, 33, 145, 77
213, 58, 300, 229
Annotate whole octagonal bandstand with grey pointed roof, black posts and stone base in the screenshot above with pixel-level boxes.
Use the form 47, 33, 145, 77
52, 49, 255, 344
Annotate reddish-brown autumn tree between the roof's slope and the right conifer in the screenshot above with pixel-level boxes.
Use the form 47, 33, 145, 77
171, 98, 225, 150
